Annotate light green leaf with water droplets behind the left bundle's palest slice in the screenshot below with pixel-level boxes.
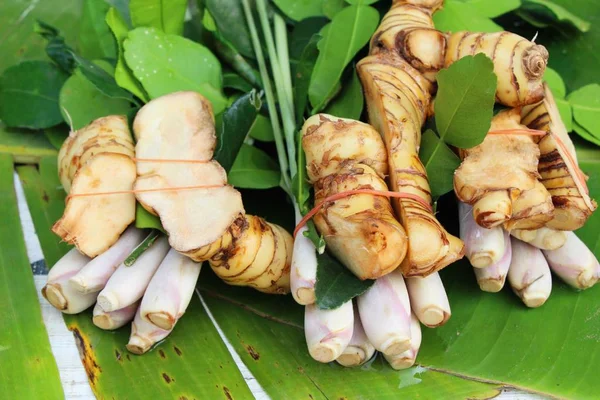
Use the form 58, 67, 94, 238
123, 28, 227, 115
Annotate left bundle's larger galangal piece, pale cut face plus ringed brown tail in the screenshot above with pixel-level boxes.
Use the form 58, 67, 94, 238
133, 92, 293, 293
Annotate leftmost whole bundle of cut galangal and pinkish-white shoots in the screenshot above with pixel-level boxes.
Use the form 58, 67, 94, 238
43, 92, 293, 354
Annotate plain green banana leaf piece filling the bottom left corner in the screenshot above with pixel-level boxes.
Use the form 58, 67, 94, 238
0, 154, 64, 399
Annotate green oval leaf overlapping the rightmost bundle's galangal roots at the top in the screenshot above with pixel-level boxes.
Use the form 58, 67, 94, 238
435, 54, 497, 149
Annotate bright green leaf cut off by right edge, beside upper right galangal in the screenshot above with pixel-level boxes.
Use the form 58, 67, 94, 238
567, 84, 600, 141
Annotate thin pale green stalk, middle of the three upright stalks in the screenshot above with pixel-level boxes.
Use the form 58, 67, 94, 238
256, 0, 297, 176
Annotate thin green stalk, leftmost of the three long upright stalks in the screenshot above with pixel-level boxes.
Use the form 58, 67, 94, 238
242, 0, 292, 197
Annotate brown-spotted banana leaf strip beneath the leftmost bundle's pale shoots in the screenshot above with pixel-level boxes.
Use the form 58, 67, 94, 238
21, 157, 252, 399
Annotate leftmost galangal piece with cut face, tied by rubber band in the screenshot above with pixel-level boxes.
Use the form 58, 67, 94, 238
52, 116, 136, 257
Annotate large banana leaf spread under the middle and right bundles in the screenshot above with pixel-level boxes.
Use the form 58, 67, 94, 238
200, 145, 600, 399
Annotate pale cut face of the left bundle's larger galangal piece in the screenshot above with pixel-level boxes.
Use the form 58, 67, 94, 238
133, 92, 244, 259
